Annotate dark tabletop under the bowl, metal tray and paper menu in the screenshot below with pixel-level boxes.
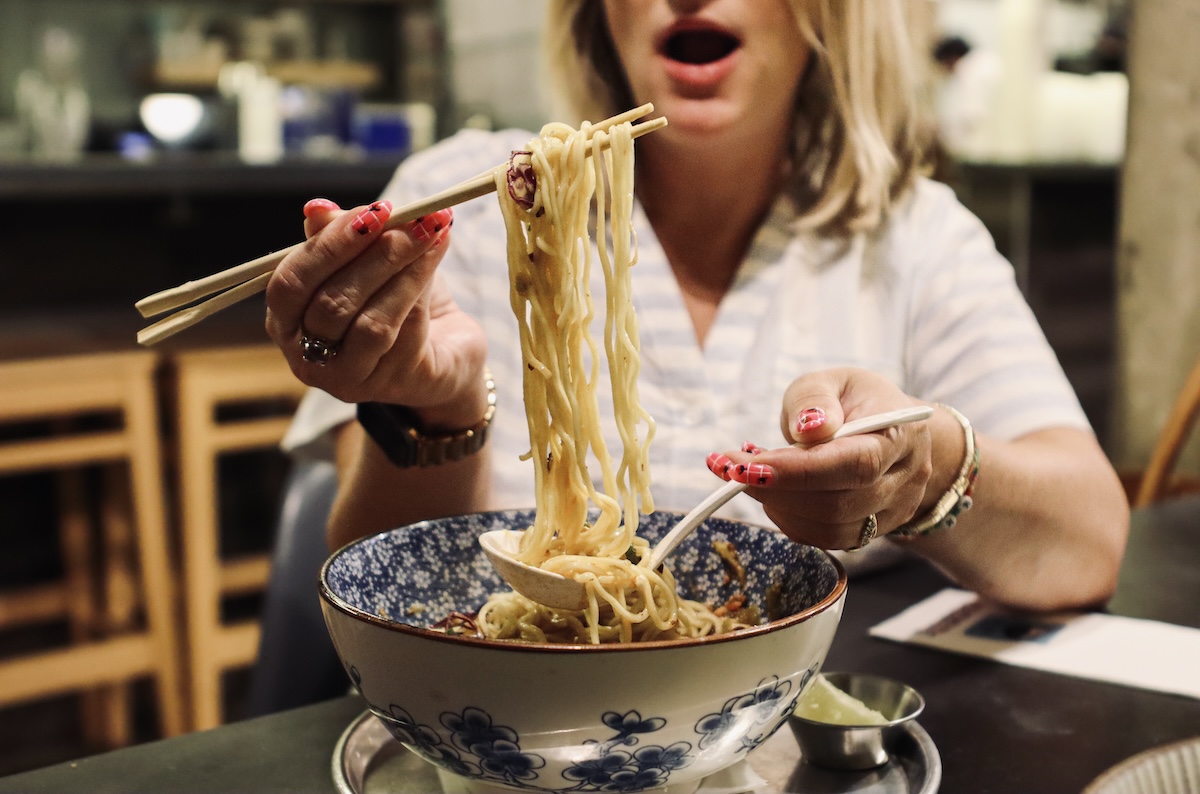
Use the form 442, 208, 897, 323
0, 498, 1200, 794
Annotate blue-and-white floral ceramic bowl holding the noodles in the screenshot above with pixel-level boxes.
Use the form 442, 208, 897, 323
320, 511, 846, 792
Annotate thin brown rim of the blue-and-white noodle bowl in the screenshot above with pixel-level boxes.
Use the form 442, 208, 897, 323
318, 507, 848, 654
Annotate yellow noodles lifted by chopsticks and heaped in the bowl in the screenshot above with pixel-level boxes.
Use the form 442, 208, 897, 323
476, 124, 740, 644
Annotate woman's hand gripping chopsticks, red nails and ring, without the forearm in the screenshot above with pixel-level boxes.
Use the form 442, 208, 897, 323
266, 199, 487, 427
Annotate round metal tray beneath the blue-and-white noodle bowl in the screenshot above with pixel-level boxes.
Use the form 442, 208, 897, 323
332, 711, 940, 794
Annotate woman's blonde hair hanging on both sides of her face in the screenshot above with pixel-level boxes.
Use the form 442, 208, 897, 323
545, 0, 928, 233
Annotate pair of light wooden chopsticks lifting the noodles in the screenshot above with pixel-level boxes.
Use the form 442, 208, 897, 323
136, 103, 667, 345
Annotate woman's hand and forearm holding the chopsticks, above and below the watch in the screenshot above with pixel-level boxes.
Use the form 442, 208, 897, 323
266, 200, 490, 547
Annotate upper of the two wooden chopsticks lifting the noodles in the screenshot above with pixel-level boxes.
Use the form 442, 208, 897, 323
134, 103, 666, 317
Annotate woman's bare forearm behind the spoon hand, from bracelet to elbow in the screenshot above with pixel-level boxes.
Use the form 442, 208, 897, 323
907, 428, 1129, 610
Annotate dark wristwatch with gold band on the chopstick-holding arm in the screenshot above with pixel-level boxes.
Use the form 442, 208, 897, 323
356, 369, 496, 469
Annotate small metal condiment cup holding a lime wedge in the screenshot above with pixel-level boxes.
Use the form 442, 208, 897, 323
787, 673, 925, 770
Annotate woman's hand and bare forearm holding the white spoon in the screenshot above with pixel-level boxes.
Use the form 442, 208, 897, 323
709, 368, 1129, 610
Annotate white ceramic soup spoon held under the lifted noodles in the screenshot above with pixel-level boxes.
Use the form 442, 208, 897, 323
479, 405, 934, 609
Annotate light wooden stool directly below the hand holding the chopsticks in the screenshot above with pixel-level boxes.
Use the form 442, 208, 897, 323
173, 345, 316, 730
